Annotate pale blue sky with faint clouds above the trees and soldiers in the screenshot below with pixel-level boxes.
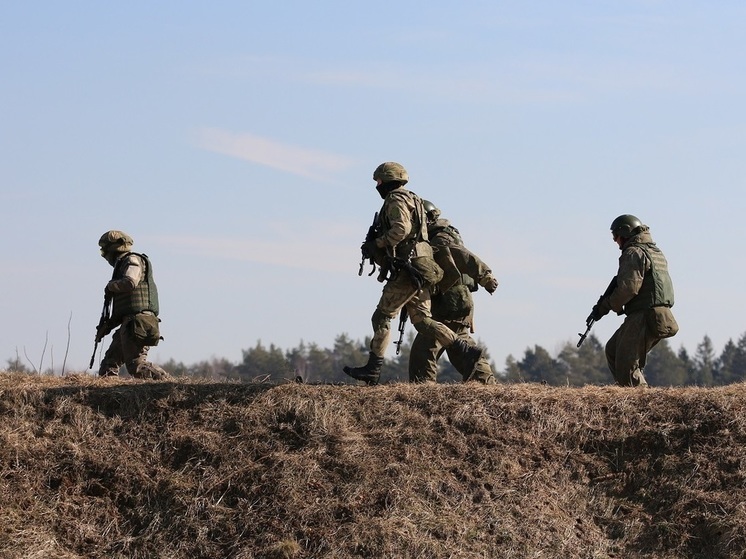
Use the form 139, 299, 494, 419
0, 0, 746, 371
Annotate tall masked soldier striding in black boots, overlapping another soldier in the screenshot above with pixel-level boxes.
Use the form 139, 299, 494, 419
343, 161, 482, 385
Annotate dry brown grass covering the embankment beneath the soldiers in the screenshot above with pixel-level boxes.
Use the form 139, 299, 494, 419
0, 374, 746, 559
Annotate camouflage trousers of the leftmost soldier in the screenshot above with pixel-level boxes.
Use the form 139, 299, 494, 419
98, 317, 170, 380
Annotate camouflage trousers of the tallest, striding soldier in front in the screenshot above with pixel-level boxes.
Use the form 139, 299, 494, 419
370, 272, 458, 357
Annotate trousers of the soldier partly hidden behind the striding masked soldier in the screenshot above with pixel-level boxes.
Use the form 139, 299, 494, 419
409, 321, 496, 384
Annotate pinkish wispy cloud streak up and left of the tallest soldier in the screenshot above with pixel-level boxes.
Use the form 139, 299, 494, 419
192, 128, 355, 181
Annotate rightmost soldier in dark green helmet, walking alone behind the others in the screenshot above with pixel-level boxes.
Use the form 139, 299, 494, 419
591, 214, 679, 387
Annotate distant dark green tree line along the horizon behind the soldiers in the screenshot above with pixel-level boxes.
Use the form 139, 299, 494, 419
148, 333, 746, 387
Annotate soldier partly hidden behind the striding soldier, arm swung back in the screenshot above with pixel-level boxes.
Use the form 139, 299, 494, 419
409, 200, 497, 384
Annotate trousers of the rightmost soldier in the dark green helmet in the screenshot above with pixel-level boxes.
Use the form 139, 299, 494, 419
606, 311, 661, 386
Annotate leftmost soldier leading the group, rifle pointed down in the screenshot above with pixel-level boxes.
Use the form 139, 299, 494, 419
96, 231, 169, 379
